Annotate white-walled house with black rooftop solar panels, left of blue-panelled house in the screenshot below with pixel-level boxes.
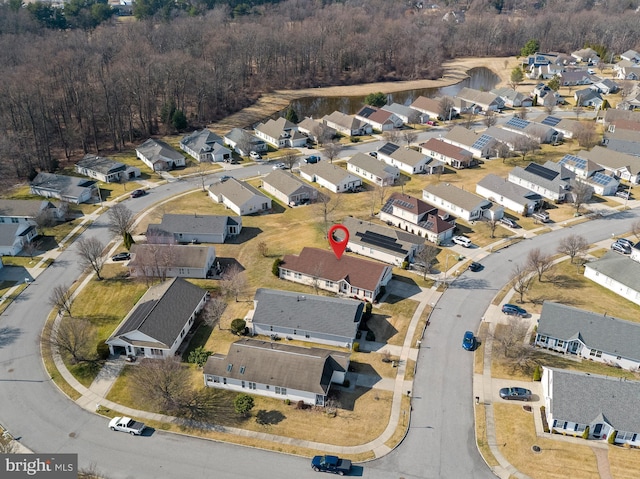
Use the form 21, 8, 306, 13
509, 162, 575, 202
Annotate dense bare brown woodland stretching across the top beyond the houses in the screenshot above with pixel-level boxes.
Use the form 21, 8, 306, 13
0, 0, 640, 184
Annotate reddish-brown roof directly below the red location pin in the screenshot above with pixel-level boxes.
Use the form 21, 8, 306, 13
280, 247, 389, 291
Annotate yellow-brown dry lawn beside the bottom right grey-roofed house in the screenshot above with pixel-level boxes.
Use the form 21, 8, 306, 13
493, 403, 600, 479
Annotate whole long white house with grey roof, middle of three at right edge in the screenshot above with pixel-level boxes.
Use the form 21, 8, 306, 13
534, 301, 640, 370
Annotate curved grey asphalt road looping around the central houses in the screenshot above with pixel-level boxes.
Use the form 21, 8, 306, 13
0, 167, 637, 479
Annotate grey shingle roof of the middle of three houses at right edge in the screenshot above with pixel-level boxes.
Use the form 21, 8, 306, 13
538, 302, 640, 360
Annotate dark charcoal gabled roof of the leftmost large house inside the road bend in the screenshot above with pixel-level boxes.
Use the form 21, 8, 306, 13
109, 278, 207, 349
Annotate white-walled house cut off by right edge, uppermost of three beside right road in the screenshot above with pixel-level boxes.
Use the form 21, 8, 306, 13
584, 251, 640, 304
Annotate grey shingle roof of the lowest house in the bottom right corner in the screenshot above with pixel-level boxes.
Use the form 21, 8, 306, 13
548, 368, 640, 432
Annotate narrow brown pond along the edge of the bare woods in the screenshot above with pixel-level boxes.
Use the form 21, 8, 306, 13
284, 67, 500, 119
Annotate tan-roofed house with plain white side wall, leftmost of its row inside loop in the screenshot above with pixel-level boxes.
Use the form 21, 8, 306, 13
208, 178, 271, 216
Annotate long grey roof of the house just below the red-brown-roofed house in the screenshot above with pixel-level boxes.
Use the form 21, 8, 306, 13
252, 288, 364, 339
